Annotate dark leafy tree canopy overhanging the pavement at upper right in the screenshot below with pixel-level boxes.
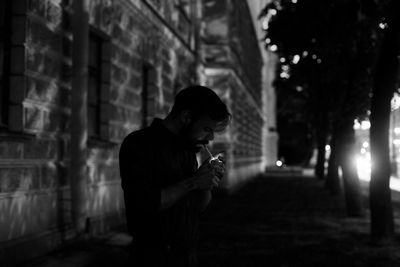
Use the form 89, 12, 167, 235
260, 0, 379, 157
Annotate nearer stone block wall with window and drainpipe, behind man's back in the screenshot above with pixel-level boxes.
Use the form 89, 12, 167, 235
0, 0, 196, 266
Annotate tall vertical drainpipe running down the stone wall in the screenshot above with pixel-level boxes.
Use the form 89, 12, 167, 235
70, 0, 89, 234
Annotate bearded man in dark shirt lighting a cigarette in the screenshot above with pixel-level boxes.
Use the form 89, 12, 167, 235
119, 86, 231, 267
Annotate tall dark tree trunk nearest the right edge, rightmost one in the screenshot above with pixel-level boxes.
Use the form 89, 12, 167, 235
370, 17, 399, 243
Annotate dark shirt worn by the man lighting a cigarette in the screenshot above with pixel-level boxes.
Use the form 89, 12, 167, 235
119, 119, 199, 266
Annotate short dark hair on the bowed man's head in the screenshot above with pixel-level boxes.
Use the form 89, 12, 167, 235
170, 85, 231, 131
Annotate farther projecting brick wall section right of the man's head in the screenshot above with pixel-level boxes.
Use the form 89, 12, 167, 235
201, 0, 270, 190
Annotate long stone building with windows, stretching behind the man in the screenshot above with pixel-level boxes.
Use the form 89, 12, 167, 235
0, 0, 277, 266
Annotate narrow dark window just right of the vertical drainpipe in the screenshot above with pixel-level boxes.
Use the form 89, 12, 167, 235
88, 32, 103, 137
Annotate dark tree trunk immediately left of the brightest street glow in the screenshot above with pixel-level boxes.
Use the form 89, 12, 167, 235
337, 119, 364, 217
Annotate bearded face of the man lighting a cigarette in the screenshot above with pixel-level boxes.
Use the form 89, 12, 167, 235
181, 116, 217, 152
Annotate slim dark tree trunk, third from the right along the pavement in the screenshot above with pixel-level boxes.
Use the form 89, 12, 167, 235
325, 133, 340, 195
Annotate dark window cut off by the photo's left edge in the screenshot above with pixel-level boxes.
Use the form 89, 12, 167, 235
0, 1, 11, 127
